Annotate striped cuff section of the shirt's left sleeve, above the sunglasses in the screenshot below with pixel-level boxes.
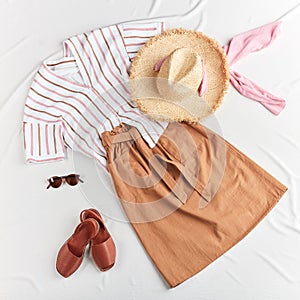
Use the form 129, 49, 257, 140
23, 121, 65, 163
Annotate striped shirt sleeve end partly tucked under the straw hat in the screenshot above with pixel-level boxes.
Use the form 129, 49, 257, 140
121, 22, 165, 61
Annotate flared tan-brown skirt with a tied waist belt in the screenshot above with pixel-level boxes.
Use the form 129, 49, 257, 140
102, 123, 287, 287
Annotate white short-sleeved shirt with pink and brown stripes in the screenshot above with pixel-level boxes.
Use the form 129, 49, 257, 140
23, 22, 167, 166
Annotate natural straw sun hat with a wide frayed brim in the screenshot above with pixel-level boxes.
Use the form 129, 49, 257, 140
130, 28, 229, 122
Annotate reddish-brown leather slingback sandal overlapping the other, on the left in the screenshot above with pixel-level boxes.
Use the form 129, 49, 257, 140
56, 219, 100, 277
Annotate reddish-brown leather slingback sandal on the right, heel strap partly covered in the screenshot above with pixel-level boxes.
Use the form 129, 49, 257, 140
80, 208, 116, 271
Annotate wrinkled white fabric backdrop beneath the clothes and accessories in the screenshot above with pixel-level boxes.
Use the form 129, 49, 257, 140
0, 0, 300, 300
